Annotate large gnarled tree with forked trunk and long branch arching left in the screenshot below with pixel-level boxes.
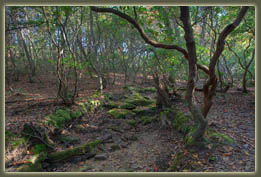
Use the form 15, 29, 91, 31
91, 6, 248, 143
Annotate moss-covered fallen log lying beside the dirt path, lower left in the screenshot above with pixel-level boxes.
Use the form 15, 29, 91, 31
48, 140, 101, 162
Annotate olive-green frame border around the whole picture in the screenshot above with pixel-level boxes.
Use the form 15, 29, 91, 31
0, 0, 260, 176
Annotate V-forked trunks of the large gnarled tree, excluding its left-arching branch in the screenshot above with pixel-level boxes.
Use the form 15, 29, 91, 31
180, 7, 248, 142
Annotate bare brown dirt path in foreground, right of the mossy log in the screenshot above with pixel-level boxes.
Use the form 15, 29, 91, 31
69, 127, 181, 172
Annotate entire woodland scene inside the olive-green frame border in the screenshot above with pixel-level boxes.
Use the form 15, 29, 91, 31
5, 6, 255, 172
